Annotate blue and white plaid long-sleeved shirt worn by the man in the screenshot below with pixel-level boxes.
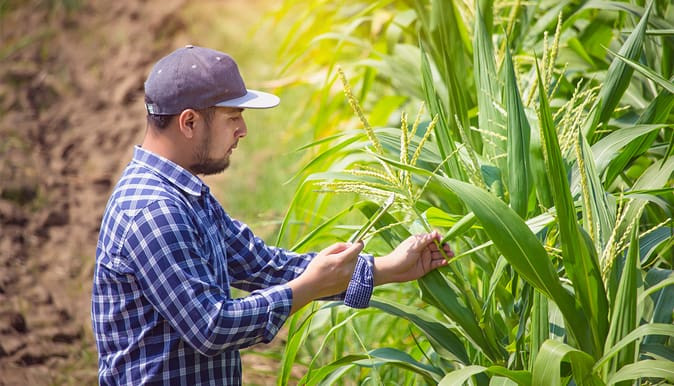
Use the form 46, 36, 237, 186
92, 147, 373, 385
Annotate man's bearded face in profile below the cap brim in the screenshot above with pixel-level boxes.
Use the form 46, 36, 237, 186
190, 107, 248, 175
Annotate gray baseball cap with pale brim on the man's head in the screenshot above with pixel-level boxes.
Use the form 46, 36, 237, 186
145, 45, 280, 115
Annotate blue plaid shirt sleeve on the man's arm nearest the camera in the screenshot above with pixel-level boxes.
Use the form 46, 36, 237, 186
124, 201, 292, 356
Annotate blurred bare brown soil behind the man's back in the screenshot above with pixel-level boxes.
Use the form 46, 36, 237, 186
0, 0, 288, 385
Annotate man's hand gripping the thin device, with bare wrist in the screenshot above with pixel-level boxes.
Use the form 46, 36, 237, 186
288, 242, 363, 313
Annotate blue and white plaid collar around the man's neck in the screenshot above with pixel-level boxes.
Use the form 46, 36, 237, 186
132, 145, 208, 196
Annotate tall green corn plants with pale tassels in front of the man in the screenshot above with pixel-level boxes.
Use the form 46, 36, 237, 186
270, 0, 674, 385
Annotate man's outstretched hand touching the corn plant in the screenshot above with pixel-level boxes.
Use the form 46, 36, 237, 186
374, 231, 454, 285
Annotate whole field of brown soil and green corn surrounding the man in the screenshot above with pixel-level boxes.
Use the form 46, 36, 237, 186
0, 0, 674, 385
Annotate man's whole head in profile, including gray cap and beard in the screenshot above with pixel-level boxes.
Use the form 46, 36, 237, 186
143, 45, 279, 174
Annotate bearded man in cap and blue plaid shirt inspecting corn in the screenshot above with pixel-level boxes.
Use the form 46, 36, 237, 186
92, 46, 452, 385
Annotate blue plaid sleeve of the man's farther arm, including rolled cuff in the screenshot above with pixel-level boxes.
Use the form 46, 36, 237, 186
226, 217, 374, 308
